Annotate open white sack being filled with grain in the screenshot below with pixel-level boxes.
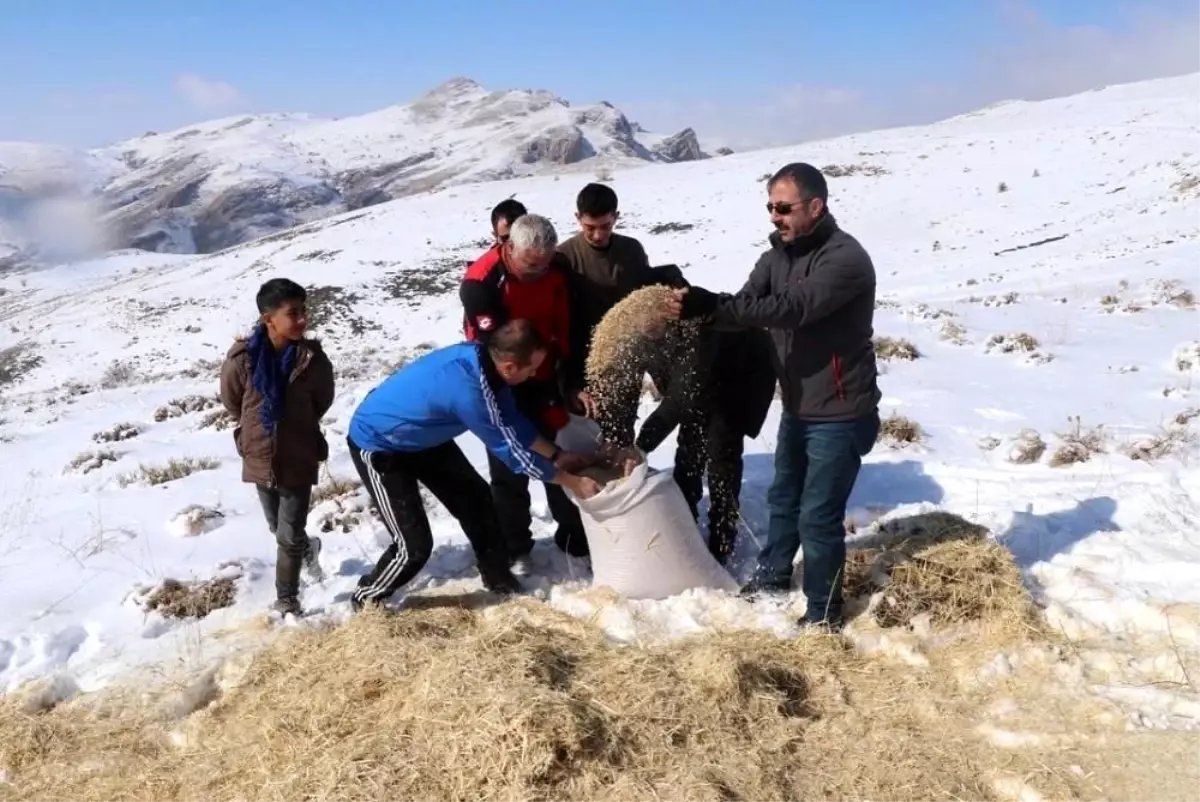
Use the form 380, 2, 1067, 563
557, 415, 738, 599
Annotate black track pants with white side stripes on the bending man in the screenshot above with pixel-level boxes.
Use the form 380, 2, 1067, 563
347, 438, 503, 603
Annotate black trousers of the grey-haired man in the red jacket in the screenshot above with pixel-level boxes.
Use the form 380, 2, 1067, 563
487, 382, 588, 557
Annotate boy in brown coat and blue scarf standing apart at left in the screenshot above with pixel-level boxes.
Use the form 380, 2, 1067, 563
221, 279, 334, 615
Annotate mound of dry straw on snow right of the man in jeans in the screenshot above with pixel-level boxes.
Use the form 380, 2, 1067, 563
845, 510, 1038, 630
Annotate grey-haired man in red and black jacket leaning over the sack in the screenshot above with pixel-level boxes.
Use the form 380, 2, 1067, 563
458, 214, 588, 562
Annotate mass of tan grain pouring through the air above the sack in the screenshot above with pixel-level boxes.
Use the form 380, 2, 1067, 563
586, 286, 698, 445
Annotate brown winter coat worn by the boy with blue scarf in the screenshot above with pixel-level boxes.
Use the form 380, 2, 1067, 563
221, 340, 334, 487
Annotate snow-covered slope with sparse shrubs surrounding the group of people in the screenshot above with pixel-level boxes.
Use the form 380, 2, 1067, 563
0, 76, 1200, 726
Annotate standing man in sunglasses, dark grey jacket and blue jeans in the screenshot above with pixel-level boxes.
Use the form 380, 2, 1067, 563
667, 163, 880, 627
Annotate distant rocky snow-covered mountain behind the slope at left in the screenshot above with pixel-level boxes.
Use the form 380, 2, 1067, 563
0, 78, 708, 265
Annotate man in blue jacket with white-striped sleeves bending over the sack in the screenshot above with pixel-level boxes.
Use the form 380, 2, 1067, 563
347, 319, 600, 610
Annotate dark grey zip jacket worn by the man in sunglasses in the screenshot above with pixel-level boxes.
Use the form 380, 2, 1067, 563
714, 213, 880, 420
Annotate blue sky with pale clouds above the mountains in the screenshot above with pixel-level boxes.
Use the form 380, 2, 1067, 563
0, 0, 1200, 146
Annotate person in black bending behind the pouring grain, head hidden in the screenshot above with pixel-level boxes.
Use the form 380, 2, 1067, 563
637, 325, 775, 564
